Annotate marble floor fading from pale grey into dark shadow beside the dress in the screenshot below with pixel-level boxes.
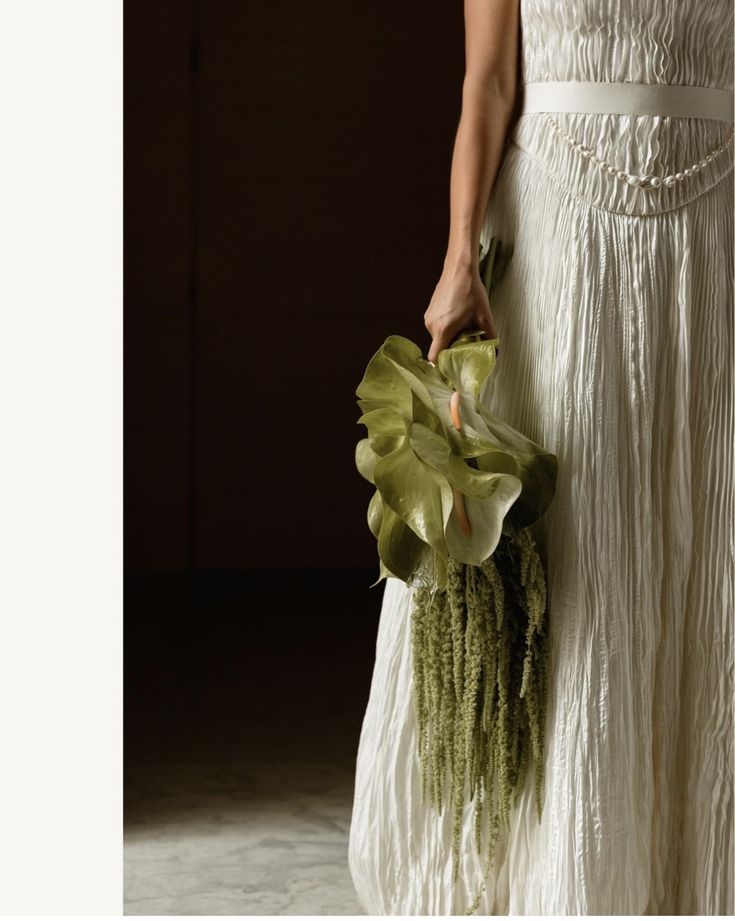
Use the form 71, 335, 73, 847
125, 573, 380, 915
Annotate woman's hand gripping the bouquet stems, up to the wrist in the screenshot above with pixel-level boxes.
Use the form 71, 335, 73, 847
424, 265, 498, 364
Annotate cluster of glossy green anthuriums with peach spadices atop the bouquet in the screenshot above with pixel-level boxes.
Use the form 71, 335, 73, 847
355, 234, 556, 582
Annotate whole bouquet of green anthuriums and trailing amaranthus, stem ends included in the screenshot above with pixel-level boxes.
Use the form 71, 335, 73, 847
355, 238, 557, 914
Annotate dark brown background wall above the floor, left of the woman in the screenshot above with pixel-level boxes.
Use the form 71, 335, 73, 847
125, 0, 463, 573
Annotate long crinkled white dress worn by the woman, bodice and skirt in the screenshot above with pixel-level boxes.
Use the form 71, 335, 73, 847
349, 0, 735, 915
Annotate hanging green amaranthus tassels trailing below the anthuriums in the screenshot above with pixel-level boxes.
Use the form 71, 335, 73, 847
411, 529, 548, 914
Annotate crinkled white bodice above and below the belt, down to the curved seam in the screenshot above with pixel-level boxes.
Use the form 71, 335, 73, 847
511, 0, 733, 215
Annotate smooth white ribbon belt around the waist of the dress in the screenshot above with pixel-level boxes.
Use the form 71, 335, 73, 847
520, 80, 735, 122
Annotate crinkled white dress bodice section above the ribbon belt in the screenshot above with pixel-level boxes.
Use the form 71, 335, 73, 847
521, 0, 733, 89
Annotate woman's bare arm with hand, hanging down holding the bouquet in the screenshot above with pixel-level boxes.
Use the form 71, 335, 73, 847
424, 0, 520, 362
